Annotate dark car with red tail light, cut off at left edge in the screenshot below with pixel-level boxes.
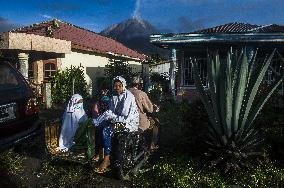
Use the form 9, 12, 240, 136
0, 60, 41, 151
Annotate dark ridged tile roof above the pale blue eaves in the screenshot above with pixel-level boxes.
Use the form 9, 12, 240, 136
192, 22, 284, 34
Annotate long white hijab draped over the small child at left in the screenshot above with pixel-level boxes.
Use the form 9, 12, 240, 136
58, 94, 87, 151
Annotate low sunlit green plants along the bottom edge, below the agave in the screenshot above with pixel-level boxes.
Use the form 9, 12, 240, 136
132, 155, 284, 188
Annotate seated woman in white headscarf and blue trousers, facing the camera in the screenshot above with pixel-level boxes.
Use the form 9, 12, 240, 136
94, 76, 139, 173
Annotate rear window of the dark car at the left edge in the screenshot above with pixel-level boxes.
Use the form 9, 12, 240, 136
0, 64, 19, 90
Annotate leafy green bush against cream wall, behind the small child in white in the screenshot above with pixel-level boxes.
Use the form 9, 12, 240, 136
51, 66, 88, 104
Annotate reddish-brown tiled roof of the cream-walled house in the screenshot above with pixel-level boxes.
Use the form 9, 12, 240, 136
11, 20, 146, 60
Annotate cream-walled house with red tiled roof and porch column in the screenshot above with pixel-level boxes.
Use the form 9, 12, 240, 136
0, 19, 146, 93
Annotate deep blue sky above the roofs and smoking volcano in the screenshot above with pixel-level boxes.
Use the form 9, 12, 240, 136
0, 0, 284, 33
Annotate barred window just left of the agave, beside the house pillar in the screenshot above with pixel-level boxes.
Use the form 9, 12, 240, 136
182, 58, 208, 87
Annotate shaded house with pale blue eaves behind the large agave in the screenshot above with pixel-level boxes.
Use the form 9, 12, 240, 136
150, 23, 284, 100
